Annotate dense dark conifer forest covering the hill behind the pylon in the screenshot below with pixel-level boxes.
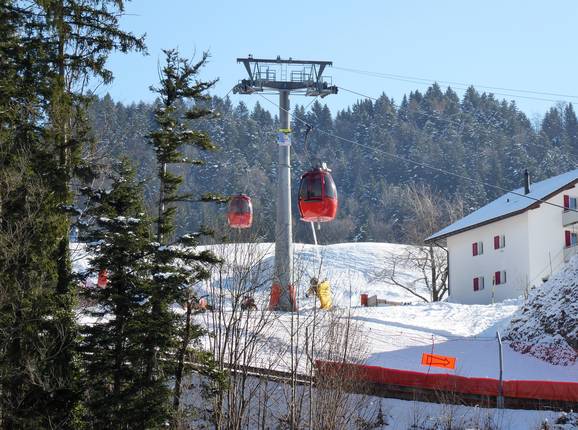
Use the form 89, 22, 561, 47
90, 84, 578, 243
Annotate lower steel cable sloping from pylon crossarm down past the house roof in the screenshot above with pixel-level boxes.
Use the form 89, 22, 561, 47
257, 93, 578, 212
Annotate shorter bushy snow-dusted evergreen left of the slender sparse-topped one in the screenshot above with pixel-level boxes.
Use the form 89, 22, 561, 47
80, 161, 169, 429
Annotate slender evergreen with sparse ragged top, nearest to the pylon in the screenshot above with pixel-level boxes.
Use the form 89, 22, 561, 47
145, 50, 219, 422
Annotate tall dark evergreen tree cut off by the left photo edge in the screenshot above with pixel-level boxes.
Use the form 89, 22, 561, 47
0, 1, 76, 429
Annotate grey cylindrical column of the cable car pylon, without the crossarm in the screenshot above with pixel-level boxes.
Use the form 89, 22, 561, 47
275, 90, 296, 311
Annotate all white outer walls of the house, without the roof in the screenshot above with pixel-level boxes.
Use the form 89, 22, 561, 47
447, 187, 578, 304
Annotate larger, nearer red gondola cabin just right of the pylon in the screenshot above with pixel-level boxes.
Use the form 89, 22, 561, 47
299, 166, 337, 222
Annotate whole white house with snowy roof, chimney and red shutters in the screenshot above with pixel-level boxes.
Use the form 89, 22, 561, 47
426, 169, 578, 304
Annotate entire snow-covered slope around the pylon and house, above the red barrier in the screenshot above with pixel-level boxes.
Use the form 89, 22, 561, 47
73, 243, 578, 382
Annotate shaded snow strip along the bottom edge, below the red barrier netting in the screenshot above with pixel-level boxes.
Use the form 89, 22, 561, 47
187, 377, 564, 430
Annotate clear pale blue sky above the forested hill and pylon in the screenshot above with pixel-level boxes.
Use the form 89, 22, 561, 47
102, 0, 578, 118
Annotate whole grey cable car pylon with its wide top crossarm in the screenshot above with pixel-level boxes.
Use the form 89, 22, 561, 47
233, 55, 337, 311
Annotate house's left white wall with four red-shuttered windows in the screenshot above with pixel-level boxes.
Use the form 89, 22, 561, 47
447, 212, 529, 304
